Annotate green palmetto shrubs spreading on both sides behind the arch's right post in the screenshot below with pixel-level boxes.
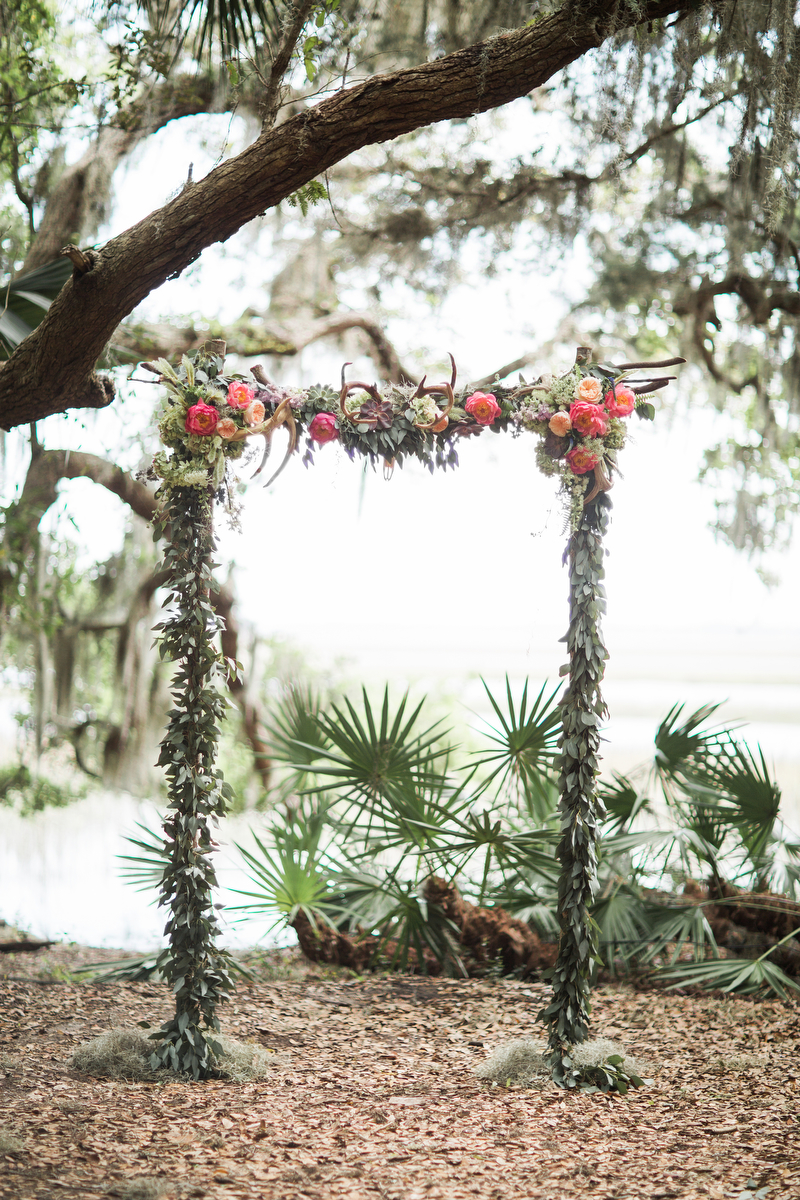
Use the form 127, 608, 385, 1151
230, 680, 800, 995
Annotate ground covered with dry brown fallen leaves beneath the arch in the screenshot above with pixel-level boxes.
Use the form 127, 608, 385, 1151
0, 946, 800, 1200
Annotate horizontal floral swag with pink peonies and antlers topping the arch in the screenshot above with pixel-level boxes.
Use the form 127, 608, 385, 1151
146, 347, 684, 530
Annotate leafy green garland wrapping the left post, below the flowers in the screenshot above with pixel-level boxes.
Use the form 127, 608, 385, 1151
151, 487, 230, 1079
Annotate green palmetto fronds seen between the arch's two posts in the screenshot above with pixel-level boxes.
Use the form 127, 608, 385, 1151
240, 685, 555, 974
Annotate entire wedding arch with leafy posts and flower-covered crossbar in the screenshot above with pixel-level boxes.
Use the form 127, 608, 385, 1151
146, 342, 684, 1091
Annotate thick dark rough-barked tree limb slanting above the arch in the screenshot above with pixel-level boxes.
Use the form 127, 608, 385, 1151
0, 0, 685, 430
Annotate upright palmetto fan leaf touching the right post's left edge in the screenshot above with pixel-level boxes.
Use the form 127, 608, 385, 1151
475, 676, 561, 823
